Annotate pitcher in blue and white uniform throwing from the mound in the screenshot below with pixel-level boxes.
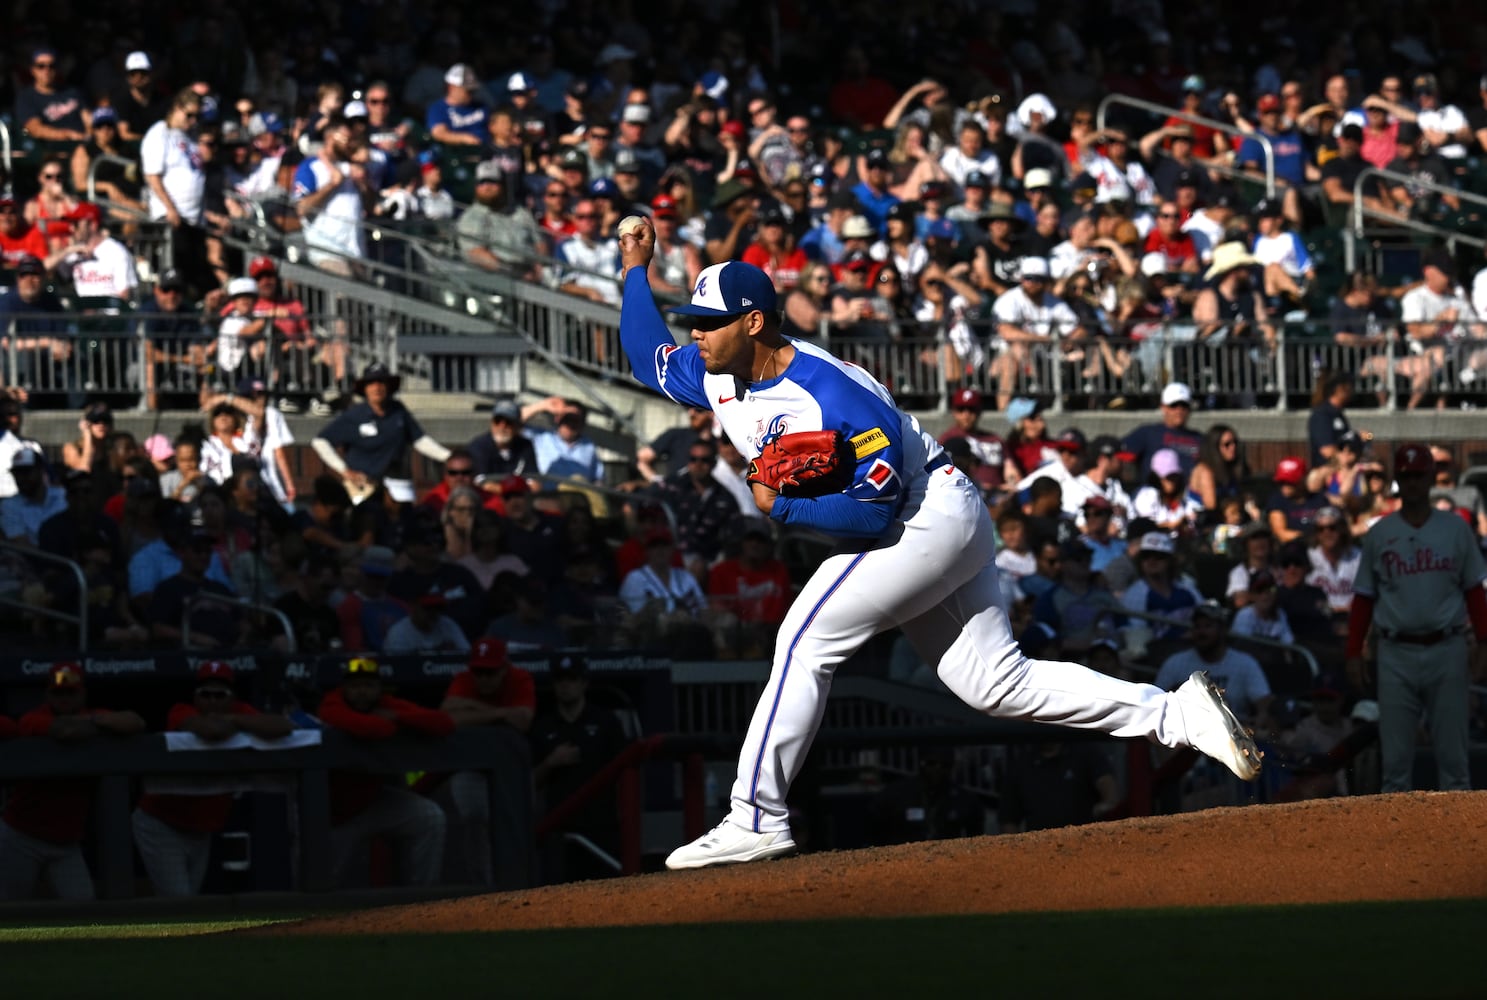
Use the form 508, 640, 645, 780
620, 222, 1259, 869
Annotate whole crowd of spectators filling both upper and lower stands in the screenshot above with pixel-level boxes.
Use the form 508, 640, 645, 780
0, 0, 1487, 894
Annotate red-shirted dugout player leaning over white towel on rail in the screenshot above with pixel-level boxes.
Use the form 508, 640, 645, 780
132, 659, 293, 896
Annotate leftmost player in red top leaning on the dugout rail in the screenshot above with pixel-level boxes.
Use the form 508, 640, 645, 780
0, 662, 144, 900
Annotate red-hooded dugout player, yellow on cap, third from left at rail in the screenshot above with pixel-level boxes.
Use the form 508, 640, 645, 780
320, 656, 455, 885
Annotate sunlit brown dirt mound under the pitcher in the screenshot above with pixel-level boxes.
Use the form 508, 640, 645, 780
276, 792, 1487, 935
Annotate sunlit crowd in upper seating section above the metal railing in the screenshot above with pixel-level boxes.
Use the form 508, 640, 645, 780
0, 3, 1487, 409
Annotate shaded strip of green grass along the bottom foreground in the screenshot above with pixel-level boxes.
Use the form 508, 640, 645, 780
0, 887, 1487, 1000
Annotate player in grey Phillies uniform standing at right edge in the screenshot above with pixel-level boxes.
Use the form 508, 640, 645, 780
1347, 443, 1487, 792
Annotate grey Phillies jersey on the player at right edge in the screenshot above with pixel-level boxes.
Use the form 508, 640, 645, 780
1353, 510, 1487, 634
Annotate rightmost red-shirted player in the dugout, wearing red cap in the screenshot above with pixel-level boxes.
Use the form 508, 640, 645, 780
439, 638, 537, 885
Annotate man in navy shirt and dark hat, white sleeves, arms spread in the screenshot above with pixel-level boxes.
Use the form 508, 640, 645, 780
311, 362, 449, 499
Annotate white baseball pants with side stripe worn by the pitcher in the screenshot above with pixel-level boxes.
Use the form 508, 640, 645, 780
729, 467, 1187, 832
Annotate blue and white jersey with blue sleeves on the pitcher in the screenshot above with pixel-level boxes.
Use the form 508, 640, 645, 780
620, 268, 950, 539
